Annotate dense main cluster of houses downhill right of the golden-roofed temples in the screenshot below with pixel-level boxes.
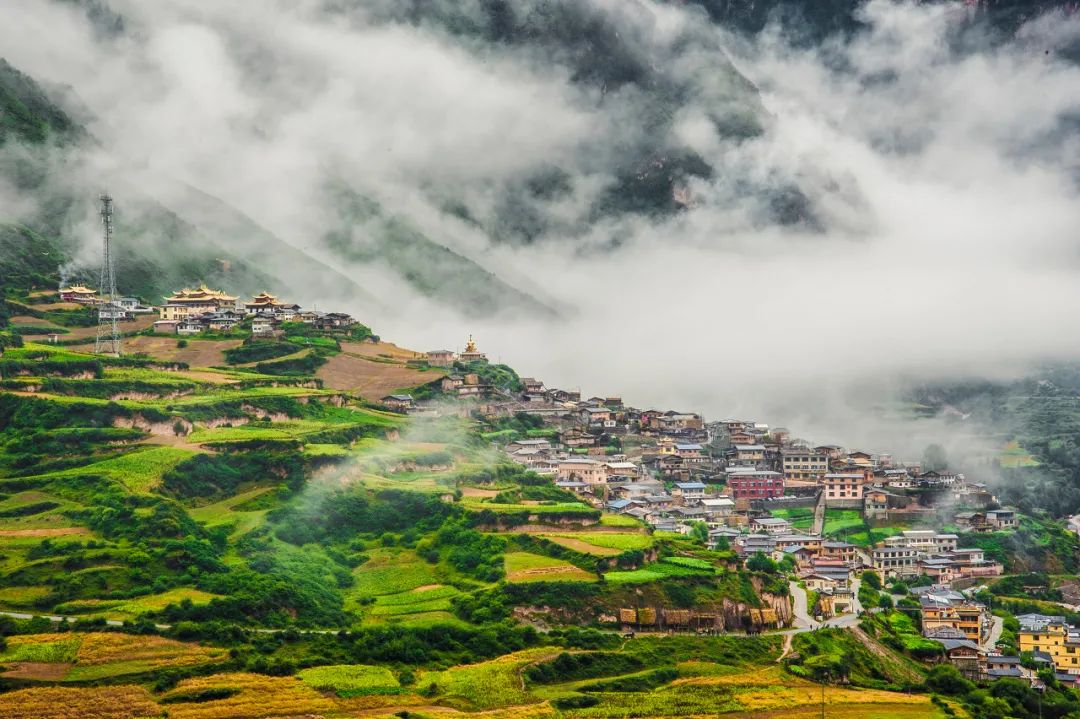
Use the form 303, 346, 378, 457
395, 369, 1045, 681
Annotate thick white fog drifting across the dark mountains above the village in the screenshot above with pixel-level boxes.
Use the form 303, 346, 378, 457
0, 0, 1080, 446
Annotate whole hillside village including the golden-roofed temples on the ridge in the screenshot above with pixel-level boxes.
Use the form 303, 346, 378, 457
6, 278, 1080, 699
